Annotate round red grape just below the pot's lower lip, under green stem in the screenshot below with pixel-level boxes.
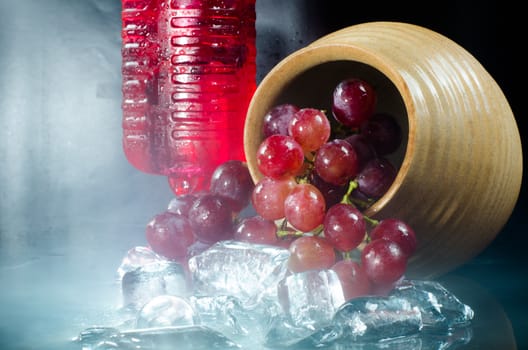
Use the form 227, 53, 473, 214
323, 203, 367, 252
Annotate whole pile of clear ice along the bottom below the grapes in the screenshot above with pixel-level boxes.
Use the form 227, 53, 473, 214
76, 241, 474, 350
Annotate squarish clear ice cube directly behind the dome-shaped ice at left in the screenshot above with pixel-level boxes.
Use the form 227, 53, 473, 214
121, 260, 188, 309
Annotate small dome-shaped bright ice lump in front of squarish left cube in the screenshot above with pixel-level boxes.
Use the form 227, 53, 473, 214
136, 295, 199, 328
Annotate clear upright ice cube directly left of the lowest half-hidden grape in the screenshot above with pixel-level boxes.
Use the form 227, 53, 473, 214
278, 270, 345, 330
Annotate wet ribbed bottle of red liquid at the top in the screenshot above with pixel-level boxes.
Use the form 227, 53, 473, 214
122, 0, 256, 195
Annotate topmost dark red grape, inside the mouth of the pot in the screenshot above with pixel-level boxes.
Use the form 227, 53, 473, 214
332, 78, 376, 128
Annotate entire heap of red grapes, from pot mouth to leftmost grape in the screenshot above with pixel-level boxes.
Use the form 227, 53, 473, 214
142, 79, 416, 299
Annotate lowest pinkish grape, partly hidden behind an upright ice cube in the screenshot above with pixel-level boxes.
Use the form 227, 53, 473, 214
331, 259, 370, 300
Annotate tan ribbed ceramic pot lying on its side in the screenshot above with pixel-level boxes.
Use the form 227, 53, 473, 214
244, 22, 522, 278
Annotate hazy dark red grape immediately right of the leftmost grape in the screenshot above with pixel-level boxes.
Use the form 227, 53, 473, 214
188, 193, 234, 243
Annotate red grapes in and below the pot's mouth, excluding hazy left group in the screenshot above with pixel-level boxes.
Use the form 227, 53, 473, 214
252, 78, 416, 299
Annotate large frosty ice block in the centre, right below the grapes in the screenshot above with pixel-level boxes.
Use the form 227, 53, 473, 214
189, 241, 290, 307
